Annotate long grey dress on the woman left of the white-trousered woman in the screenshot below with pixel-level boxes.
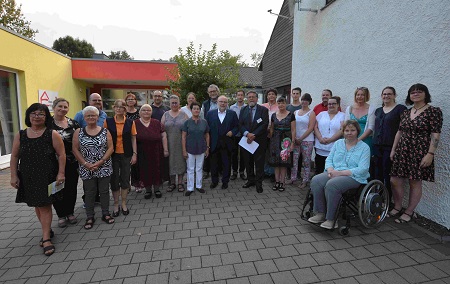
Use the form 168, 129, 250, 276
164, 112, 187, 175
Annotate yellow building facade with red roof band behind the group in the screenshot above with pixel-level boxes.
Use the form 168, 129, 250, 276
0, 25, 177, 168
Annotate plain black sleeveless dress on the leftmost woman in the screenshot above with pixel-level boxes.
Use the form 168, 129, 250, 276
16, 128, 61, 207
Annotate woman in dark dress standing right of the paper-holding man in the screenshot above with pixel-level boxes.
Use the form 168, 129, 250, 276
269, 97, 296, 191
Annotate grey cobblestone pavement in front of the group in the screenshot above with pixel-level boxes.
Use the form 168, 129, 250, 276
0, 170, 450, 284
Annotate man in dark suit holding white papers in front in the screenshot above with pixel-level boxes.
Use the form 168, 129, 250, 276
239, 91, 269, 193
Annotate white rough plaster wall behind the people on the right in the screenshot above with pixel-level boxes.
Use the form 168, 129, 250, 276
292, 0, 450, 228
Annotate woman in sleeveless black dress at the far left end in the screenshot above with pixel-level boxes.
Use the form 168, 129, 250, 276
10, 103, 66, 256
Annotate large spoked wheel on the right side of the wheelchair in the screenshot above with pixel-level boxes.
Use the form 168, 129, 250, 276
358, 180, 389, 228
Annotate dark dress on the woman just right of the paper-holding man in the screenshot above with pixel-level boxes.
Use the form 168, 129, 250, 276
269, 113, 295, 168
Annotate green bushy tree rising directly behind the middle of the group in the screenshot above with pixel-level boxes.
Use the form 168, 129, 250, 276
168, 42, 242, 104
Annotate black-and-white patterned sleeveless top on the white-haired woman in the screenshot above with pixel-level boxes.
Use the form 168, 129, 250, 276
78, 128, 112, 180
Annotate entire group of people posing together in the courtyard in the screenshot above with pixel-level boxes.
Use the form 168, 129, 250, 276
11, 84, 442, 256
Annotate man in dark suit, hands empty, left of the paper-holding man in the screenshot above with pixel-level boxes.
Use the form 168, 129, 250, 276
206, 96, 239, 189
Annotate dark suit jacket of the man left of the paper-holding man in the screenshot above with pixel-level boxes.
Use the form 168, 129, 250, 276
205, 109, 239, 152
